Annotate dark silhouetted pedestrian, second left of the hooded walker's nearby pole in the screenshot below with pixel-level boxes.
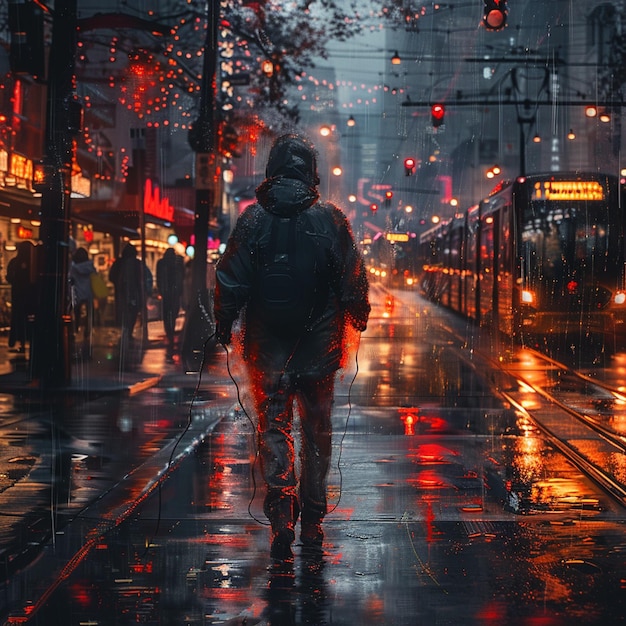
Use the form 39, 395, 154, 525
109, 243, 152, 348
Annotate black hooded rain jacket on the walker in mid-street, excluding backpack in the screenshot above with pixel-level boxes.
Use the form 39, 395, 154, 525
214, 135, 370, 376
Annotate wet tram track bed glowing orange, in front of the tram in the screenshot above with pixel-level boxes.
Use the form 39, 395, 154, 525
386, 291, 626, 507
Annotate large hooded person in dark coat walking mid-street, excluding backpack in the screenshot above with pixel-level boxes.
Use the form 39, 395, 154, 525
214, 135, 370, 565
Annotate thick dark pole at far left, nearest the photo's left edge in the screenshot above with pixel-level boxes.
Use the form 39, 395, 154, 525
31, 0, 80, 387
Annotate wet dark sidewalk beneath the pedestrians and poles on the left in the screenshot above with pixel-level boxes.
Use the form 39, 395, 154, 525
0, 317, 224, 604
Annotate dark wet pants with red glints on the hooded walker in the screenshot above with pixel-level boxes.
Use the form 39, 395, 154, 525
252, 371, 335, 532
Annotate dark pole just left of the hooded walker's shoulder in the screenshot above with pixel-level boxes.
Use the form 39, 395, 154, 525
181, 2, 219, 372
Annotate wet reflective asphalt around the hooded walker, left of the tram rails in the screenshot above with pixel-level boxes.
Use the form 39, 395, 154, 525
0, 288, 626, 626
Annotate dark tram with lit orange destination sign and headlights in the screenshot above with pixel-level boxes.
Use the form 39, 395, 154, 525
418, 173, 626, 343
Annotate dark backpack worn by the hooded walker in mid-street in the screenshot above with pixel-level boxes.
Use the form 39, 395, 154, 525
251, 215, 328, 334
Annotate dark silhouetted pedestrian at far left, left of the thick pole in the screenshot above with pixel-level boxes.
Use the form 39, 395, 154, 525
6, 241, 36, 353
